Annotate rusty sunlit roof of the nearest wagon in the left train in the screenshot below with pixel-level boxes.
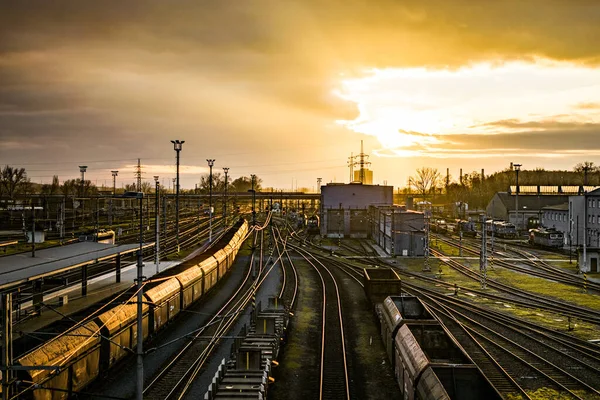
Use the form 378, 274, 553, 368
17, 321, 100, 383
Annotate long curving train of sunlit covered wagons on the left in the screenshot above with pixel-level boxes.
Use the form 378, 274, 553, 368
15, 219, 248, 400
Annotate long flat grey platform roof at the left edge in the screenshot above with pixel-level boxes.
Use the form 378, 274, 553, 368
0, 242, 154, 289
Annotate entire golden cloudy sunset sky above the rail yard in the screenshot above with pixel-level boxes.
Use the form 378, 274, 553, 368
0, 0, 600, 190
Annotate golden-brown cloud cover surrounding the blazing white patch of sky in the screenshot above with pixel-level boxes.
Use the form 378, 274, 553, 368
0, 0, 600, 186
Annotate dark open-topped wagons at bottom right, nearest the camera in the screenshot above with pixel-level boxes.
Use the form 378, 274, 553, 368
375, 295, 501, 400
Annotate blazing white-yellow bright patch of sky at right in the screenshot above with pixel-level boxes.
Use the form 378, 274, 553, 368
336, 59, 600, 158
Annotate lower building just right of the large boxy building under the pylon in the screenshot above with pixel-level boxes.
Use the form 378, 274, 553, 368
369, 206, 425, 257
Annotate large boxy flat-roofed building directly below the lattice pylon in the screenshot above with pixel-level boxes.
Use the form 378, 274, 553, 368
320, 183, 394, 238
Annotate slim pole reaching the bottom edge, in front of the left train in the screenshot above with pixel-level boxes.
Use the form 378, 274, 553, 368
123, 192, 144, 400
